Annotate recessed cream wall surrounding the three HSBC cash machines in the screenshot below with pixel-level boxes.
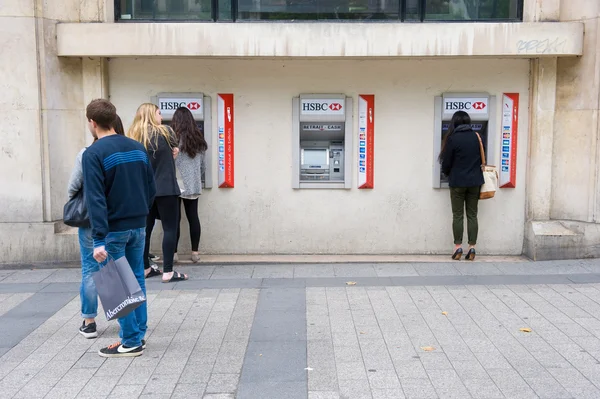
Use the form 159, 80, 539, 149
109, 59, 529, 254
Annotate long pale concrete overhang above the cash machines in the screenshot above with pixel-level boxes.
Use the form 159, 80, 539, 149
57, 22, 584, 58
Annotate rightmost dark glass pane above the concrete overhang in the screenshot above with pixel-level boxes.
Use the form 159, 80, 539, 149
425, 0, 522, 21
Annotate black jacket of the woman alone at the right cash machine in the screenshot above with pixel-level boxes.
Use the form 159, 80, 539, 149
442, 125, 483, 187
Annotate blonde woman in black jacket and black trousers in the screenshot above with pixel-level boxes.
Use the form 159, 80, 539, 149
127, 103, 188, 283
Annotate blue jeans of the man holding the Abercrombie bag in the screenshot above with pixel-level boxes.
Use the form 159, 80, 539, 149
105, 227, 148, 347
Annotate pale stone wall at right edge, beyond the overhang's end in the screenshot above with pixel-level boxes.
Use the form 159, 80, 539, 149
551, 0, 600, 222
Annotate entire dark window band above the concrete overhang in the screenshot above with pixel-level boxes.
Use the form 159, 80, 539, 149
115, 0, 524, 22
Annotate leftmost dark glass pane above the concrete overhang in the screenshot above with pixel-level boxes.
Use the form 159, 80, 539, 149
117, 0, 212, 21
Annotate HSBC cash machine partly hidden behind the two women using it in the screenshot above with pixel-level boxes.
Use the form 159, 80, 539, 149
152, 93, 212, 188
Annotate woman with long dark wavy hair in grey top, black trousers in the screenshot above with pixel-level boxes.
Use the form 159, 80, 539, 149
171, 107, 208, 263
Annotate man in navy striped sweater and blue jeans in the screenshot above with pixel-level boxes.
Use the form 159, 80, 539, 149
82, 99, 156, 357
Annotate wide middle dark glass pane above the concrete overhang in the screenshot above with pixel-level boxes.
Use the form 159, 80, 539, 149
238, 0, 400, 20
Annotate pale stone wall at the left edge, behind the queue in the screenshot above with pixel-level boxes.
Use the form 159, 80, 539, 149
0, 0, 104, 263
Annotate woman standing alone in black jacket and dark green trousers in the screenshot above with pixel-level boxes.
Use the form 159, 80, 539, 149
439, 111, 484, 260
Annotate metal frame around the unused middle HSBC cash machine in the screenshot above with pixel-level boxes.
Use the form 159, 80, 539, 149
292, 94, 355, 189
